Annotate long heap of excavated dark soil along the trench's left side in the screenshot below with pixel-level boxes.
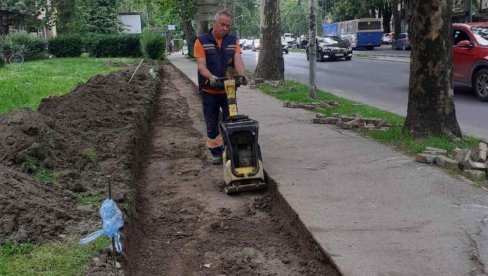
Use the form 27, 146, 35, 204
0, 61, 159, 242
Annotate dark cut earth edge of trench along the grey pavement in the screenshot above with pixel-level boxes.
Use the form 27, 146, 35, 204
169, 61, 345, 276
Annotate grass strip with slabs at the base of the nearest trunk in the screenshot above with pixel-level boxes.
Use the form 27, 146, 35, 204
261, 81, 480, 154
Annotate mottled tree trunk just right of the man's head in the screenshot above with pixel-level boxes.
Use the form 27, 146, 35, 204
254, 0, 285, 80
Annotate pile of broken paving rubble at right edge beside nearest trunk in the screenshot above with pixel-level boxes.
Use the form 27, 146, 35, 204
415, 142, 488, 182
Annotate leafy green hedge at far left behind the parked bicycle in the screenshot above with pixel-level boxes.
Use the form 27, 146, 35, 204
0, 33, 47, 61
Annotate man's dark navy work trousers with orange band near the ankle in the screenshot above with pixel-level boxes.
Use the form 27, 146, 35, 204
200, 90, 229, 156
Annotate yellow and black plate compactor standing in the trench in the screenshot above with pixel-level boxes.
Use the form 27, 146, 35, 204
220, 76, 267, 194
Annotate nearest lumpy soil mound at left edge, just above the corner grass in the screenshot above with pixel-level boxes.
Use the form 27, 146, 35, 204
0, 166, 89, 242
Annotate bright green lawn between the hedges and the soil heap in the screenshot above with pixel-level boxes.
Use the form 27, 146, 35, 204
0, 57, 136, 114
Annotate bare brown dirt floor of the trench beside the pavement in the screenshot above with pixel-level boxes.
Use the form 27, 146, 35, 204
123, 64, 339, 275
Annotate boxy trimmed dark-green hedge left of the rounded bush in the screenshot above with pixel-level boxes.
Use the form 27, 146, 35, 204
85, 35, 142, 57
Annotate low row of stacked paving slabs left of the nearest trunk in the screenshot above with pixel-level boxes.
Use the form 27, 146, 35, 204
313, 113, 389, 130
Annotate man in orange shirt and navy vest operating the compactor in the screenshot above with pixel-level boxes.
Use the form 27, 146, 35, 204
194, 10, 247, 165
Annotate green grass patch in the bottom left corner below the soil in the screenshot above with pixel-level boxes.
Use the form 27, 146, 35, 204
0, 236, 110, 276
